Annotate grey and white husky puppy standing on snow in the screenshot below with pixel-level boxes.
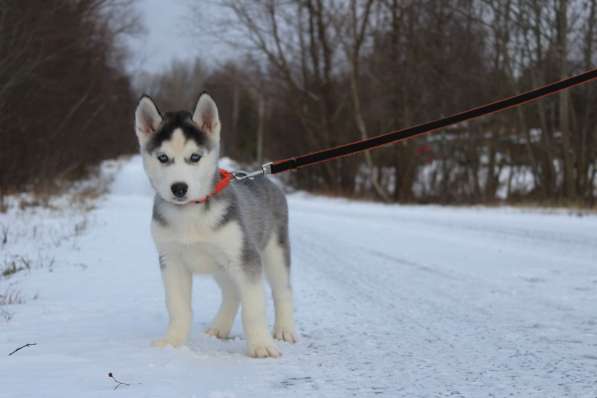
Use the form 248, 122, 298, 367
135, 93, 296, 358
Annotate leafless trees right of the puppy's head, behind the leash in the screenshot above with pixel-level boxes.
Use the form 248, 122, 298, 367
169, 0, 597, 205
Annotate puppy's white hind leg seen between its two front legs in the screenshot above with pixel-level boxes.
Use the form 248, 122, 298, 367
205, 272, 240, 339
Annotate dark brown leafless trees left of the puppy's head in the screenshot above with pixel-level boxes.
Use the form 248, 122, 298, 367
0, 0, 139, 199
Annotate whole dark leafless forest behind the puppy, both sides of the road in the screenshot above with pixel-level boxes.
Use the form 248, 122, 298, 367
0, 0, 597, 207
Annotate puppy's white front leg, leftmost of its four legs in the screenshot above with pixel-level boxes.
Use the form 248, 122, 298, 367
152, 256, 193, 347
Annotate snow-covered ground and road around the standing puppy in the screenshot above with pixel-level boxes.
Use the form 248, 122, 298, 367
0, 158, 597, 398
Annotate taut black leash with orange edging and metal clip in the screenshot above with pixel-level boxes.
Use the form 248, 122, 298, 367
233, 69, 597, 181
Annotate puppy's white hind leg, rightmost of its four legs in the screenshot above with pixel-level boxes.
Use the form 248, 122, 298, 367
263, 234, 297, 343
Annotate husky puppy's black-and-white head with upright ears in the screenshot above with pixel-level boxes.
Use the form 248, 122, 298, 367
135, 93, 220, 205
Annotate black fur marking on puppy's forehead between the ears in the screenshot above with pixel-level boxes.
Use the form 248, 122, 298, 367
145, 111, 211, 153
